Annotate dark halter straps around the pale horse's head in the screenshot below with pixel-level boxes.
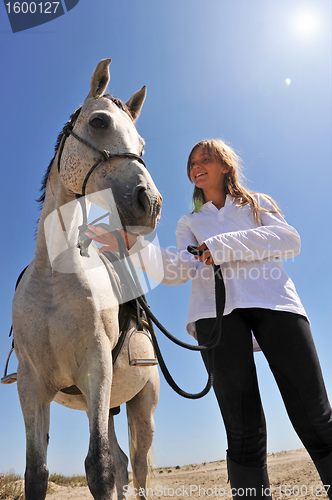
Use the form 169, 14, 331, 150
58, 108, 146, 257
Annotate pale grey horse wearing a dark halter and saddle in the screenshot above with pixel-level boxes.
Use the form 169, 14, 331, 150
12, 59, 162, 500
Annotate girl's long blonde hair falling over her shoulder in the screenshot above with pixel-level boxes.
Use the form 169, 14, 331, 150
187, 139, 282, 224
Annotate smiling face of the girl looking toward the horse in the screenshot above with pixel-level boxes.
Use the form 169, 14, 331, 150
190, 146, 229, 193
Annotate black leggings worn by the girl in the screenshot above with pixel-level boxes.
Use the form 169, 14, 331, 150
196, 308, 332, 467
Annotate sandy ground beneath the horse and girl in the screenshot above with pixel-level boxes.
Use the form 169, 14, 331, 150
41, 450, 327, 500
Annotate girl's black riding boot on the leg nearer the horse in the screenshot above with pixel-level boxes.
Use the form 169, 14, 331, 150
227, 456, 272, 500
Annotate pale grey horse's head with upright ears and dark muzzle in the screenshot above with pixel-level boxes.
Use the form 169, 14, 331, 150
59, 59, 161, 234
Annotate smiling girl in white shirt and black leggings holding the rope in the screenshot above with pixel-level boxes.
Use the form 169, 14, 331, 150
89, 140, 332, 498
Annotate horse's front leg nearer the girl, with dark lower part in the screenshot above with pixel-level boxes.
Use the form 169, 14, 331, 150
80, 345, 115, 500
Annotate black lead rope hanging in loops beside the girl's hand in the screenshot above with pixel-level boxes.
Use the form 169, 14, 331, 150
108, 231, 225, 399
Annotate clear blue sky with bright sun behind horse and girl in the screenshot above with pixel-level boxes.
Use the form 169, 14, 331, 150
0, 0, 332, 474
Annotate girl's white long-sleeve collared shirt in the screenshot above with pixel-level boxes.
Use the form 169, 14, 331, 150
130, 195, 306, 337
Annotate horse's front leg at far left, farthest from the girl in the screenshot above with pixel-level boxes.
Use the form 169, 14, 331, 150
17, 363, 52, 500
